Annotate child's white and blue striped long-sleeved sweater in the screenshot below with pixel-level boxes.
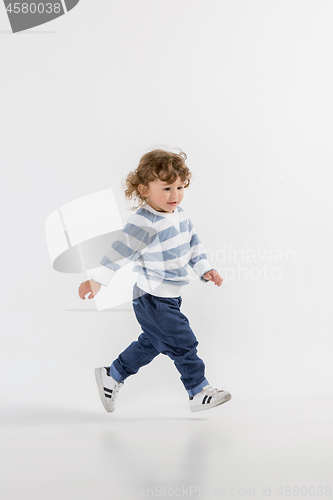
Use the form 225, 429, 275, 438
89, 204, 213, 297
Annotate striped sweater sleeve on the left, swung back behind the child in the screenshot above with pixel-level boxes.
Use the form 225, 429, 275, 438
88, 214, 156, 286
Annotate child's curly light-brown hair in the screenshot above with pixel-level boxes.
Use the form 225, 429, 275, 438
122, 149, 192, 210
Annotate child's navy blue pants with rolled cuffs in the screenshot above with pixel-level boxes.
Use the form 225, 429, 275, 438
110, 284, 208, 396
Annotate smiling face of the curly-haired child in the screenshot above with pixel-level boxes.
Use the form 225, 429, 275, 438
140, 177, 185, 213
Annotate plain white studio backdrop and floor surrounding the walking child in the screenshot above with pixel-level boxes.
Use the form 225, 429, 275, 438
0, 0, 333, 500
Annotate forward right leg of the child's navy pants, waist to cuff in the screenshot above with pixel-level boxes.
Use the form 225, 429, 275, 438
133, 293, 208, 395
